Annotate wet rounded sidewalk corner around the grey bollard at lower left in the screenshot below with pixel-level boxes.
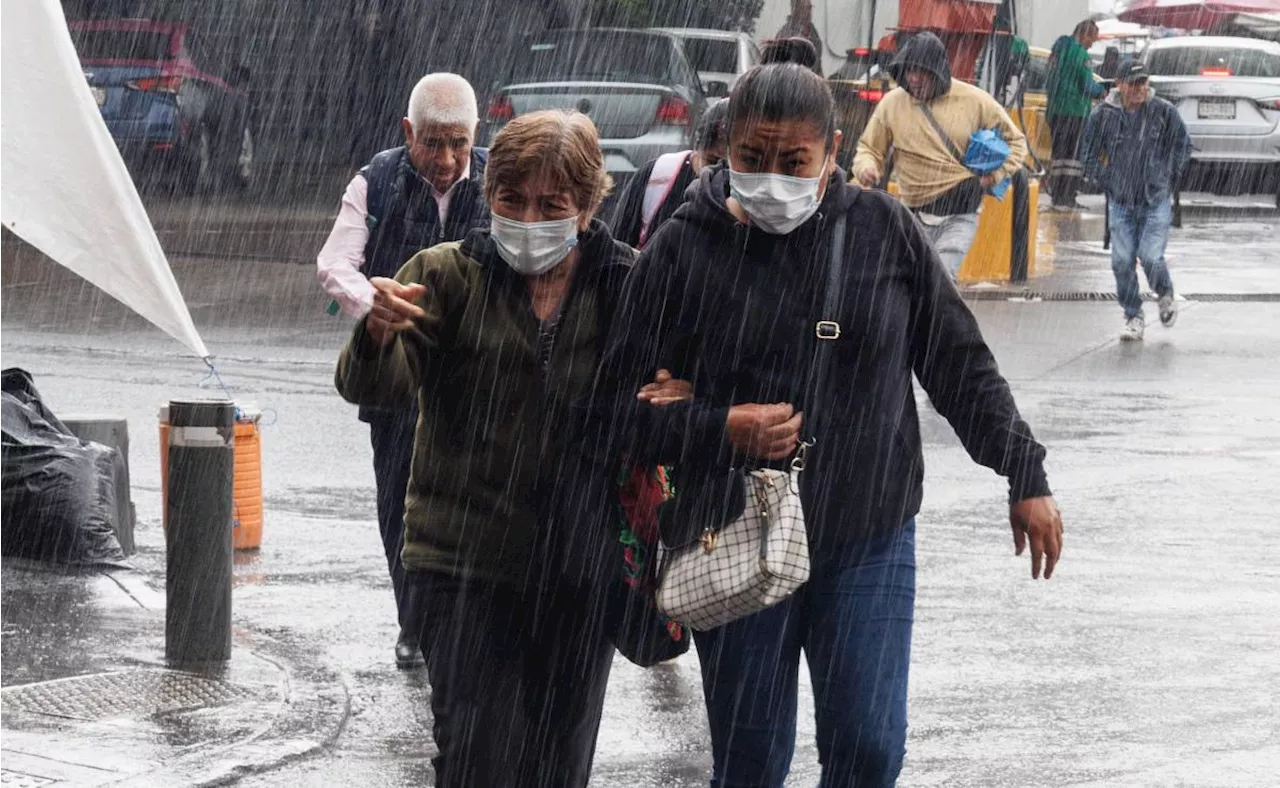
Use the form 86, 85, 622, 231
0, 559, 348, 788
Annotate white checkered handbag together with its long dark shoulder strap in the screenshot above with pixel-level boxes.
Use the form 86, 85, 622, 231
654, 215, 846, 631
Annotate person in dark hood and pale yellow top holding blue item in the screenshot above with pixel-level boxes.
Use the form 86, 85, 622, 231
852, 33, 1027, 280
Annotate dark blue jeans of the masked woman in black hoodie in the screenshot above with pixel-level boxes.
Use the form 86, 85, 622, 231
694, 521, 915, 788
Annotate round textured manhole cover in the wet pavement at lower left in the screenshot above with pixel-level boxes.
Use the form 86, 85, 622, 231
0, 670, 253, 721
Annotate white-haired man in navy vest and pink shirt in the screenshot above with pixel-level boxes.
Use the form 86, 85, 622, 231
316, 73, 489, 668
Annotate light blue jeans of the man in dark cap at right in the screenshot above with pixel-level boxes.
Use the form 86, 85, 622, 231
1107, 200, 1174, 320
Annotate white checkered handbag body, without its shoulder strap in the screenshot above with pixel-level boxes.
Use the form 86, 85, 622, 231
655, 469, 809, 631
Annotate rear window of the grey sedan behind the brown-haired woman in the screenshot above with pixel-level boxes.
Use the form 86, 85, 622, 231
511, 31, 672, 84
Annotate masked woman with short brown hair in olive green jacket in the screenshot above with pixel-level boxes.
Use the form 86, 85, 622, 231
337, 111, 682, 788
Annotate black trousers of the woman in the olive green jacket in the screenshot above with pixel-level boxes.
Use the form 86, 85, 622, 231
408, 572, 613, 788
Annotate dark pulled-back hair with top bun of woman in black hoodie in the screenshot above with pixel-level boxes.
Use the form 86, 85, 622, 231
728, 60, 836, 146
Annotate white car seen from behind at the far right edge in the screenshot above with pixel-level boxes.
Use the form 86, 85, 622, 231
1146, 36, 1280, 194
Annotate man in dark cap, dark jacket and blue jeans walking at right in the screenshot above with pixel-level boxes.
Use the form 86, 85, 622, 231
1080, 60, 1192, 342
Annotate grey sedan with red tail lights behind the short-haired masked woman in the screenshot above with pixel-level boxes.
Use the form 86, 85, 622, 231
485, 28, 707, 184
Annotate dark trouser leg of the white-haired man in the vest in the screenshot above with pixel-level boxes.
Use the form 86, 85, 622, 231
369, 407, 417, 628
